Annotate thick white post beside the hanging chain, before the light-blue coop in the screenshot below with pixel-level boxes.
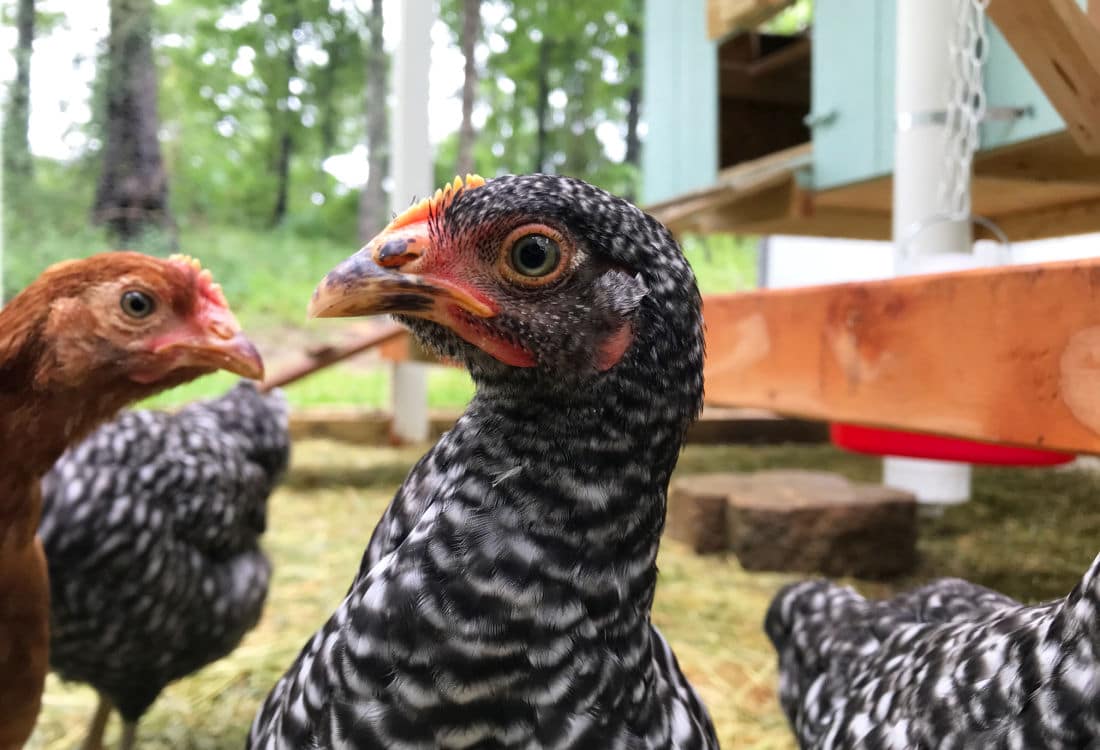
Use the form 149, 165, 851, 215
883, 0, 976, 504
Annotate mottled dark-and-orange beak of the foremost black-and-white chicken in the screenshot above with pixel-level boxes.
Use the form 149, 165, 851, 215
309, 222, 496, 323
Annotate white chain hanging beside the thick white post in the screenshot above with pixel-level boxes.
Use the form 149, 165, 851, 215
939, 0, 989, 221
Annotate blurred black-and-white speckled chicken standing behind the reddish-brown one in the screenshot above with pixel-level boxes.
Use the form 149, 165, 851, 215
39, 380, 289, 748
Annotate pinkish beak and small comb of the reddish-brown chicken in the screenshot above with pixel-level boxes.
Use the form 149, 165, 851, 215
154, 306, 264, 380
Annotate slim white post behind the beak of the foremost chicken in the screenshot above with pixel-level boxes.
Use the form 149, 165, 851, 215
391, 0, 436, 442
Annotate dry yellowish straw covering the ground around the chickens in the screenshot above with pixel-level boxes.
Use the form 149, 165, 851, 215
30, 441, 1100, 750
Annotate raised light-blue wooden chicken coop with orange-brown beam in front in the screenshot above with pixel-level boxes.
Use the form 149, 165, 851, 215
644, 0, 1100, 501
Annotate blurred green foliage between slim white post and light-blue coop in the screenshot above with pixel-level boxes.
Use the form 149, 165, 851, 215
436, 0, 642, 195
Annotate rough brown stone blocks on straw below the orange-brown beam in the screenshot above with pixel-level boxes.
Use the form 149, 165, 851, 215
668, 471, 917, 578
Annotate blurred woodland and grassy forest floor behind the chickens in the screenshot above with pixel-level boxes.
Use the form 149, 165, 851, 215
2, 0, 787, 402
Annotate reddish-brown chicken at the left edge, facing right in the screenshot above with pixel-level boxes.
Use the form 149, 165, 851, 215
0, 253, 263, 750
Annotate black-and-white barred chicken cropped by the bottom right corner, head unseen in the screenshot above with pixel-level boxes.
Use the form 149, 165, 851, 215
766, 558, 1100, 750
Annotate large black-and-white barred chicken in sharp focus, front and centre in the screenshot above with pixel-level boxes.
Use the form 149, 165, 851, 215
249, 175, 717, 749
